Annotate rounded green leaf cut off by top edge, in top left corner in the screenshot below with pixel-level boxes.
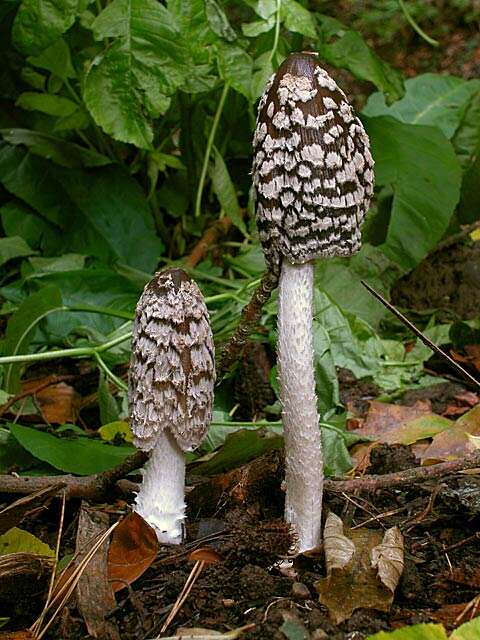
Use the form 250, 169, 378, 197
12, 0, 78, 55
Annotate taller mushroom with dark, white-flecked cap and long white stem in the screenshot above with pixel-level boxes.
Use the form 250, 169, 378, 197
253, 53, 373, 552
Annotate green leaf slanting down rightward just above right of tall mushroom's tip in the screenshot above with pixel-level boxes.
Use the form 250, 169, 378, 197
317, 14, 403, 101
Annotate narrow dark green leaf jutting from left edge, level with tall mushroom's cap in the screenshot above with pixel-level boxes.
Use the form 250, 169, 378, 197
0, 129, 112, 169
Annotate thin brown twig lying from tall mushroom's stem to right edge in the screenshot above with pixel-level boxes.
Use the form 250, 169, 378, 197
324, 452, 480, 493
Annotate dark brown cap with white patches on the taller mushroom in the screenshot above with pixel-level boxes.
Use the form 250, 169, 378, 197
253, 53, 374, 266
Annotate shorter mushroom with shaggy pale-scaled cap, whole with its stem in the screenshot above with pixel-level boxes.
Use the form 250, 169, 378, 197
129, 269, 215, 544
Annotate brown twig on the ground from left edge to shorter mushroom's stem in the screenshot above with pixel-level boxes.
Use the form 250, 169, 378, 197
0, 451, 148, 502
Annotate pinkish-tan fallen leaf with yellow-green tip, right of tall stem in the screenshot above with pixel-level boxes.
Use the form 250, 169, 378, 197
353, 400, 452, 444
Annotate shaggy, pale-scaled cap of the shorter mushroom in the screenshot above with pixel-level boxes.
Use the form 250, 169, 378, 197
128, 269, 215, 451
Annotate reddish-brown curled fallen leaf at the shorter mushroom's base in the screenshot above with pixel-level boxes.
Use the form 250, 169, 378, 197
108, 511, 158, 592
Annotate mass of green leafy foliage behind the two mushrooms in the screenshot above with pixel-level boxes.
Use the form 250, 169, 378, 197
0, 0, 480, 474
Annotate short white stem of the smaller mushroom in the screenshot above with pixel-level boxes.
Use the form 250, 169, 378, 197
134, 429, 185, 544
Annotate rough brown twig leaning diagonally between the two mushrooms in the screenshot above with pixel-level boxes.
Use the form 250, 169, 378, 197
217, 270, 280, 378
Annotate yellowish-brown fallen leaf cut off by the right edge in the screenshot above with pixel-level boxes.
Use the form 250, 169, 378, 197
420, 404, 480, 464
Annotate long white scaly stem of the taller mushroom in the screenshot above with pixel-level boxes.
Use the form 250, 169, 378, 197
278, 260, 323, 552
